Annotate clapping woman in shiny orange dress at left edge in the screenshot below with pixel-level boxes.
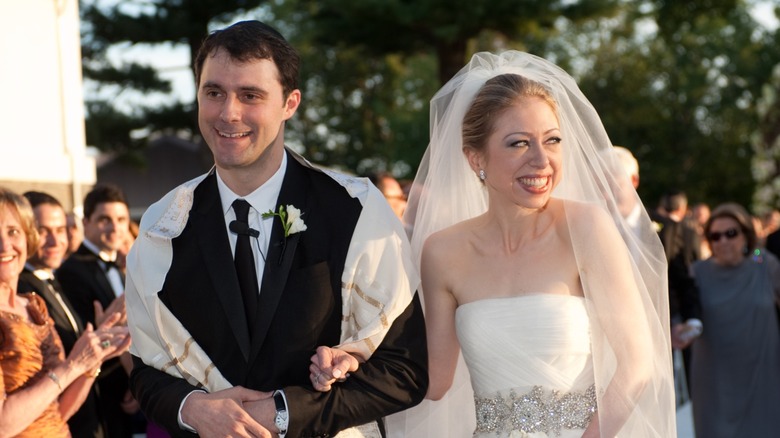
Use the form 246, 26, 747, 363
0, 188, 130, 437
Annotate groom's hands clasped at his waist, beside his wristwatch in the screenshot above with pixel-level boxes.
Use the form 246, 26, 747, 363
181, 386, 274, 438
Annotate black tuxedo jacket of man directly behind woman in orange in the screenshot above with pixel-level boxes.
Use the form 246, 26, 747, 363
17, 267, 103, 438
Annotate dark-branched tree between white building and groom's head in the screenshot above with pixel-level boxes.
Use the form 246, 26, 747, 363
80, 0, 263, 165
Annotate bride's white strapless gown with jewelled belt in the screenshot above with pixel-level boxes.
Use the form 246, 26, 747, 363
456, 294, 596, 438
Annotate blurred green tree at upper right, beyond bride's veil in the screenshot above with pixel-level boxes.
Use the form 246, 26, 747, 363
581, 0, 780, 207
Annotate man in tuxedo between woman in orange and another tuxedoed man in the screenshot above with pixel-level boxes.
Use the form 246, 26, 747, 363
17, 191, 103, 438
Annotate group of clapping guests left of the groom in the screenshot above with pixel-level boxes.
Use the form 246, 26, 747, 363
0, 185, 148, 438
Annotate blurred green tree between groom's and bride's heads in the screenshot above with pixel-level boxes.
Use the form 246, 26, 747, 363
272, 0, 618, 178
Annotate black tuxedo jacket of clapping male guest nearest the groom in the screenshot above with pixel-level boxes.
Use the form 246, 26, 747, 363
55, 244, 138, 438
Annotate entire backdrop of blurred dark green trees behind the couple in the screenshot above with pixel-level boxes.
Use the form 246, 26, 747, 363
83, 0, 780, 206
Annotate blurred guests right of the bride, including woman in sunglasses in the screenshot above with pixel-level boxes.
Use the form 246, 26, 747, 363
616, 147, 780, 437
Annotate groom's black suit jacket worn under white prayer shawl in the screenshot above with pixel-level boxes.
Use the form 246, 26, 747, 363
131, 150, 428, 437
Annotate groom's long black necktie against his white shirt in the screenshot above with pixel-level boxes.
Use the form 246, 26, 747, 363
233, 199, 260, 334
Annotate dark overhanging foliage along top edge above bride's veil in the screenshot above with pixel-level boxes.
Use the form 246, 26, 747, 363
290, 0, 617, 84
